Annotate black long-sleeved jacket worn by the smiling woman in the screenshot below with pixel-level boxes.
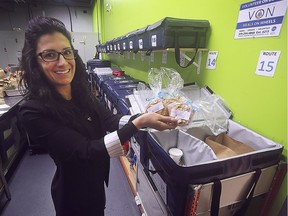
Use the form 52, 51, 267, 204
20, 100, 135, 216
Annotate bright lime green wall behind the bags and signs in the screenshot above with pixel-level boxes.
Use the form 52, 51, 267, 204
94, 0, 287, 215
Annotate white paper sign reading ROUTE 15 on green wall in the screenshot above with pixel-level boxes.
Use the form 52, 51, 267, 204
256, 50, 281, 77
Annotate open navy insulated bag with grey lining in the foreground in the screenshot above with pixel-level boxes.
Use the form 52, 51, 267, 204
144, 120, 282, 216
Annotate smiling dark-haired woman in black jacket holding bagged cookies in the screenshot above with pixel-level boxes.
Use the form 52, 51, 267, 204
20, 17, 177, 216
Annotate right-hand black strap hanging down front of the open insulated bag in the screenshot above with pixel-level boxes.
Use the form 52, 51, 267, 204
234, 169, 261, 216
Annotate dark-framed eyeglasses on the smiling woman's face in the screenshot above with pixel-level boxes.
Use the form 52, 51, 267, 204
38, 49, 77, 62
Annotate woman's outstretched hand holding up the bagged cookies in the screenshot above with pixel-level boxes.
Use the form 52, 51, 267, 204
132, 112, 177, 131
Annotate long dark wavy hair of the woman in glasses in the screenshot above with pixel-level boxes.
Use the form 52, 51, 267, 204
19, 17, 94, 123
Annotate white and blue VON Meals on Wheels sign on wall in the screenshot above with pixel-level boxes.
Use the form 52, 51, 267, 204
234, 0, 287, 39
